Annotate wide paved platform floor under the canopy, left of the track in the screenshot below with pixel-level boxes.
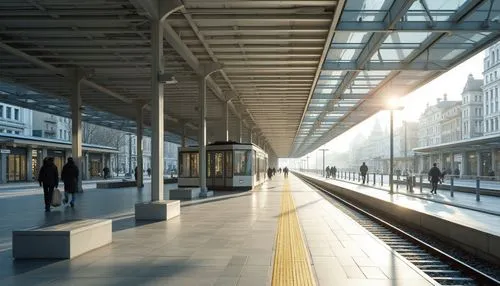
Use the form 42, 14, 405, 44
0, 175, 433, 285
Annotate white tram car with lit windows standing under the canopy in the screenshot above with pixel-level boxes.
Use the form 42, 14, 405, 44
177, 142, 267, 191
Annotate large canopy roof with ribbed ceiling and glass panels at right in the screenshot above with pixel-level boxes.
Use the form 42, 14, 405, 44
0, 0, 500, 157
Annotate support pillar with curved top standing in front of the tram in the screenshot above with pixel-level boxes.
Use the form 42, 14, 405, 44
198, 63, 223, 197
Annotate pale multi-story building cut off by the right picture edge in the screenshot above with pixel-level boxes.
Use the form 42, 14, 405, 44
483, 42, 500, 135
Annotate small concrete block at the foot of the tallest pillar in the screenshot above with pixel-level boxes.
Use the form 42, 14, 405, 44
135, 200, 181, 220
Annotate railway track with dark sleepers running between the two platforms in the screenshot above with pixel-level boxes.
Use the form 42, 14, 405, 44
300, 177, 500, 286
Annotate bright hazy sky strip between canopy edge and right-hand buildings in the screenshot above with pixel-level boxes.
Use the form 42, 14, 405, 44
311, 49, 484, 159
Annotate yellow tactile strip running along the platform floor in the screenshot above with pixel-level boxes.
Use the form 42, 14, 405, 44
272, 180, 315, 286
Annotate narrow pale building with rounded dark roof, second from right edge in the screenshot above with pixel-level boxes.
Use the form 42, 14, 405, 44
461, 74, 483, 139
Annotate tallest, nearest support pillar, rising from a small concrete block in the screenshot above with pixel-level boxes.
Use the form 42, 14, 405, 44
151, 19, 164, 202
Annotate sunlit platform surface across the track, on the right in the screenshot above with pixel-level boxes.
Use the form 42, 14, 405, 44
303, 173, 500, 236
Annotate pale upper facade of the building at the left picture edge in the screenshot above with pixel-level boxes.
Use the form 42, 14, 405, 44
0, 103, 33, 136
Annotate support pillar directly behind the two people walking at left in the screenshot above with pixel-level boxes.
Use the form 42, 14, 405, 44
71, 70, 83, 192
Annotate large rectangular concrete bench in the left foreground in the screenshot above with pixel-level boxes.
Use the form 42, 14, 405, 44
12, 219, 112, 259
